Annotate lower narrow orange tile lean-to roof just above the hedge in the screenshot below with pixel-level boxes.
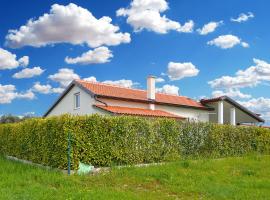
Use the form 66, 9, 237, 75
95, 105, 185, 119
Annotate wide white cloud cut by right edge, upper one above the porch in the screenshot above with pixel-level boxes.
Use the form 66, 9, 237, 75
208, 59, 270, 88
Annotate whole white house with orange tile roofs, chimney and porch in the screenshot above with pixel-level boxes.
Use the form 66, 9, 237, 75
44, 76, 264, 125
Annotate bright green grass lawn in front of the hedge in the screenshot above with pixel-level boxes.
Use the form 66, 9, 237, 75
0, 155, 270, 200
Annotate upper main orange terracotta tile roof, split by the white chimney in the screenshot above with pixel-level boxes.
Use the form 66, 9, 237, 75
76, 80, 208, 110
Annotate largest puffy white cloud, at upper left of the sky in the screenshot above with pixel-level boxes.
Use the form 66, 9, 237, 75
6, 3, 130, 48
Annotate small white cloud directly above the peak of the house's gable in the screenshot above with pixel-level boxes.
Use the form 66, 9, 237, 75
48, 68, 80, 87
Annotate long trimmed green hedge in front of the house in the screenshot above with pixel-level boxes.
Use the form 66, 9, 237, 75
0, 115, 270, 169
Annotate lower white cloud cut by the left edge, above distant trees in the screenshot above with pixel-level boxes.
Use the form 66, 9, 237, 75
0, 84, 35, 104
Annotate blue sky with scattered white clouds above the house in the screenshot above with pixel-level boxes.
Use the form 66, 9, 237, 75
0, 0, 270, 124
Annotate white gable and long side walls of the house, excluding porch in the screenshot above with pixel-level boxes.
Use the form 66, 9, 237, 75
47, 85, 209, 122
